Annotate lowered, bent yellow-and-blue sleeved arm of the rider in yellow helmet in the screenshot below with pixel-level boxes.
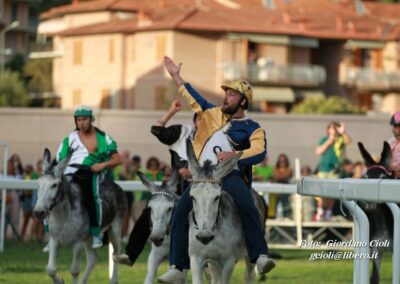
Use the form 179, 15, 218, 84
239, 127, 267, 166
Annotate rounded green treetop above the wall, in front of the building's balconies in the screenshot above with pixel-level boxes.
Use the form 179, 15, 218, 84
292, 96, 365, 114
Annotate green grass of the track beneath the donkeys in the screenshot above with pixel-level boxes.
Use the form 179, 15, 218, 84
0, 241, 392, 284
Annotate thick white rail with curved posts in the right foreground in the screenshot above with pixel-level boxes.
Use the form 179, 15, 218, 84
297, 177, 400, 284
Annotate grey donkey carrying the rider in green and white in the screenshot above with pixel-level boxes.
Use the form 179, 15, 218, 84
33, 148, 127, 284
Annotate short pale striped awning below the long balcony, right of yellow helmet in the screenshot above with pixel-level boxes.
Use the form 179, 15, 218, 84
253, 87, 295, 103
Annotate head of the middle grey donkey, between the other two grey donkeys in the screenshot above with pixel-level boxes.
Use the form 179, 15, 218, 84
138, 170, 179, 246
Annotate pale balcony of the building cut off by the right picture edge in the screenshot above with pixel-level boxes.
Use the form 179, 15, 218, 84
345, 68, 400, 90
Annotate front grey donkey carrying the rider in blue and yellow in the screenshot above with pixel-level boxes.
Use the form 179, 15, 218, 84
187, 142, 266, 284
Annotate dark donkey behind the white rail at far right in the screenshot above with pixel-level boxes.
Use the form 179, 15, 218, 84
358, 142, 394, 284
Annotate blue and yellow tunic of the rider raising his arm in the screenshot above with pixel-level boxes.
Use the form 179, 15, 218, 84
179, 83, 267, 186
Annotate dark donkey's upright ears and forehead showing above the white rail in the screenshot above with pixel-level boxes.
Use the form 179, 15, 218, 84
357, 141, 394, 179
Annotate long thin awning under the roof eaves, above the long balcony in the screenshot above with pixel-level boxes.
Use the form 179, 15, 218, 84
228, 33, 319, 48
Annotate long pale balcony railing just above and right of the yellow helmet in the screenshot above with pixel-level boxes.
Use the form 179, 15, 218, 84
223, 62, 326, 86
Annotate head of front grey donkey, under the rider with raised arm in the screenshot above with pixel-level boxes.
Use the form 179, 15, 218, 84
186, 140, 240, 244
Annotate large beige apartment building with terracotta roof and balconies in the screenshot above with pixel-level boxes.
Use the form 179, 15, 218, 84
39, 0, 400, 113
